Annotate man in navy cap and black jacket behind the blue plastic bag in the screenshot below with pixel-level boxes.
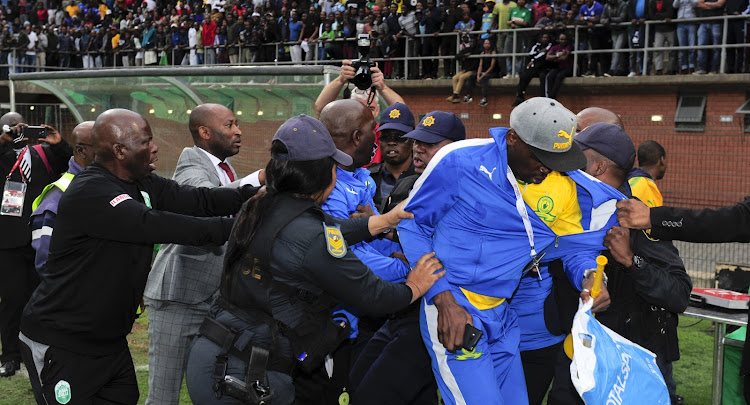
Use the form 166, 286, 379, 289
549, 123, 692, 404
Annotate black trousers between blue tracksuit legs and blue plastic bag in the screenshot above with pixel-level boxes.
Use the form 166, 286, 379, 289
521, 342, 562, 405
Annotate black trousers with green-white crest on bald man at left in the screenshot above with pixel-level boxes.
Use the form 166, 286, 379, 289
21, 343, 140, 405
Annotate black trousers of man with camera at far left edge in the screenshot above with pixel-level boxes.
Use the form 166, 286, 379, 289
0, 245, 39, 363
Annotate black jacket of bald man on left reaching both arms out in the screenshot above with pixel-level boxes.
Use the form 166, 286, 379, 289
21, 164, 255, 355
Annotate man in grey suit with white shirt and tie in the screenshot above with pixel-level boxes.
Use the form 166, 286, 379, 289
144, 104, 263, 405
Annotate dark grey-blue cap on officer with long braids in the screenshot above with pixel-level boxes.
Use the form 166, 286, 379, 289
273, 114, 352, 166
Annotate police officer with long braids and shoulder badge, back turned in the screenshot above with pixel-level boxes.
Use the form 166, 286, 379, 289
187, 115, 444, 405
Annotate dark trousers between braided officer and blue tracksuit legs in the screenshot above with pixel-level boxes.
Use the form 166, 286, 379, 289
349, 305, 437, 405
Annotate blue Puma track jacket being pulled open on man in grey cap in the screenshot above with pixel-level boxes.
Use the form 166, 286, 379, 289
398, 128, 625, 303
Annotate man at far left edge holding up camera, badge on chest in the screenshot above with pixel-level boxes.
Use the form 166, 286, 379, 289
0, 112, 72, 377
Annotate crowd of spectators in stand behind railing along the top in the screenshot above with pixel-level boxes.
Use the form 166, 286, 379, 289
0, 0, 750, 79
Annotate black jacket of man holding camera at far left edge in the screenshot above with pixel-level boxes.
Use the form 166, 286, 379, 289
0, 140, 73, 249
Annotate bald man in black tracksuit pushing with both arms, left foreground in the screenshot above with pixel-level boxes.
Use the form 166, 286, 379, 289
20, 109, 256, 404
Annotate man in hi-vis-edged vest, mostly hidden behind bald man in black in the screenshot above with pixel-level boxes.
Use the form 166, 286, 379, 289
30, 121, 94, 272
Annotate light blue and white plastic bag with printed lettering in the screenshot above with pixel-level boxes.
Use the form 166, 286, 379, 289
570, 300, 670, 405
